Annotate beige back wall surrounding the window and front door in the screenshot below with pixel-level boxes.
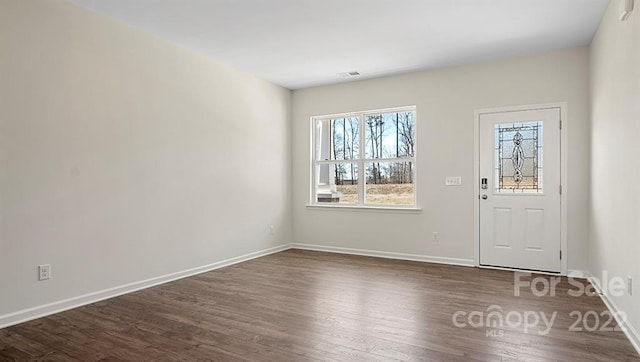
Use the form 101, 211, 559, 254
292, 47, 589, 270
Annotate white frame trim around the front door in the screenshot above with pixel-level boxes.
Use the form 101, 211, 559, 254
473, 102, 569, 275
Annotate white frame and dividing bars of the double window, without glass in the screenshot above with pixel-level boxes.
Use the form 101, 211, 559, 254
307, 106, 420, 211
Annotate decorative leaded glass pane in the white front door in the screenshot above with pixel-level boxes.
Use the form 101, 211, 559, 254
494, 122, 543, 193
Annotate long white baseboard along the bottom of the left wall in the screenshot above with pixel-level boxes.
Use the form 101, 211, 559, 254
0, 244, 291, 329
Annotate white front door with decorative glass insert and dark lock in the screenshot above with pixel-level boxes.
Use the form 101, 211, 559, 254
478, 108, 561, 272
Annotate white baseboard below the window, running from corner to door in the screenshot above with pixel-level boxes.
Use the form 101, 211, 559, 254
291, 243, 475, 267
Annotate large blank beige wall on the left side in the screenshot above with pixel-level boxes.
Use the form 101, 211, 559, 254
0, 0, 291, 325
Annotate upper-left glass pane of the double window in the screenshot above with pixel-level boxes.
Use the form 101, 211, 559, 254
315, 117, 360, 161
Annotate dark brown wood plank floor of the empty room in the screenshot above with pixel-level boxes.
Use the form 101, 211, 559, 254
0, 250, 640, 361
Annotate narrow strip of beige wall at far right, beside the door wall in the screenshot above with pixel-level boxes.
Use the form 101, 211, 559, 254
589, 0, 640, 350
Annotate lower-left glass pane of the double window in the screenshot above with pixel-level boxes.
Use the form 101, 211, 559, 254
316, 163, 358, 204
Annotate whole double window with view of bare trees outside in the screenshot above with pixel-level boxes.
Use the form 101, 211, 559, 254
311, 107, 416, 207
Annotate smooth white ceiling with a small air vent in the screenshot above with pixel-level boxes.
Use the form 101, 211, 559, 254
72, 0, 609, 89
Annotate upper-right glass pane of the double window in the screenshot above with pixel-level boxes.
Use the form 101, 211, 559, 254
364, 111, 416, 159
